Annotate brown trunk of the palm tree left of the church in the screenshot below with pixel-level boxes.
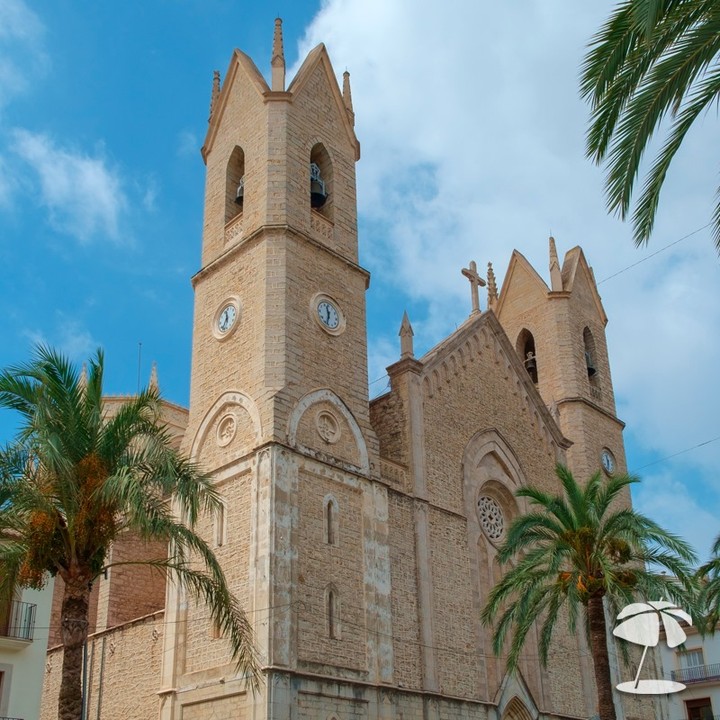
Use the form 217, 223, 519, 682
58, 581, 90, 720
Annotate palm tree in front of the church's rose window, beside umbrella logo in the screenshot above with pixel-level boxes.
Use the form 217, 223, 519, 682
482, 465, 694, 720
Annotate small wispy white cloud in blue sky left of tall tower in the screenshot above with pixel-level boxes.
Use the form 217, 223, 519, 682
13, 129, 128, 243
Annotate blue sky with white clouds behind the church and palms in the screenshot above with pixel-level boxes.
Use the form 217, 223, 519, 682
0, 0, 720, 554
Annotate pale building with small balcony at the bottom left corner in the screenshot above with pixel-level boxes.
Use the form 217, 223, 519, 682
0, 579, 53, 720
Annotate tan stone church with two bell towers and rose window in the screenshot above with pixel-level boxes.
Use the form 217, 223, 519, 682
42, 20, 654, 720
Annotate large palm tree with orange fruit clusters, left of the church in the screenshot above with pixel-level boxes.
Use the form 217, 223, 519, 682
0, 347, 258, 720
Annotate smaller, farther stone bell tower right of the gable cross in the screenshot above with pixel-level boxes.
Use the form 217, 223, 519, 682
494, 237, 626, 479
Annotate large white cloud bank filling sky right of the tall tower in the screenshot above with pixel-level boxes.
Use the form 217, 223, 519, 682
290, 0, 720, 534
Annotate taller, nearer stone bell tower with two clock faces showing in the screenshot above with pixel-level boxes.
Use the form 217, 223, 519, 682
161, 20, 392, 720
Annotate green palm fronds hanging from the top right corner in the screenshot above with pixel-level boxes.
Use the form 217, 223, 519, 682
581, 0, 720, 252
